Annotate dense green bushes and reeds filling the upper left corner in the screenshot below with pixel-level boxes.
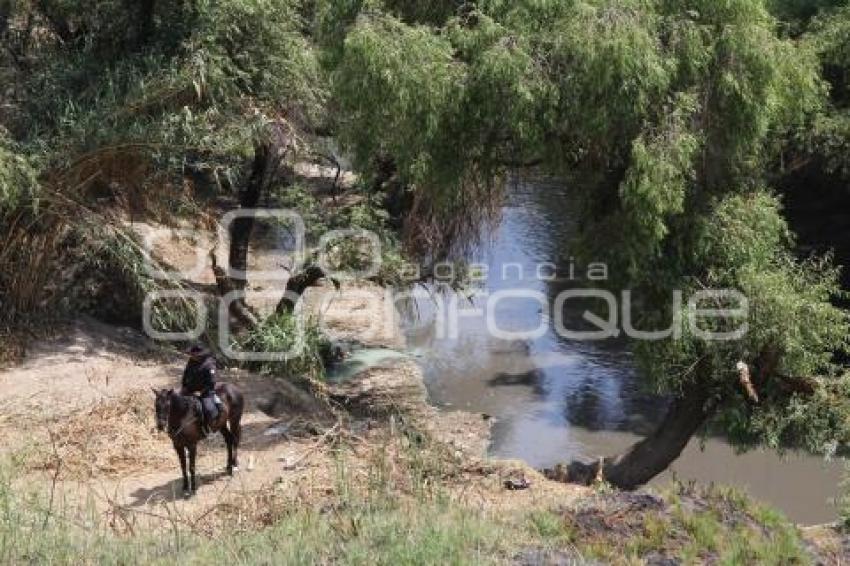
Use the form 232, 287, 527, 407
0, 0, 327, 329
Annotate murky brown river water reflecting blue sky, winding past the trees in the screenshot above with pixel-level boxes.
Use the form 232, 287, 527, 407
408, 181, 842, 523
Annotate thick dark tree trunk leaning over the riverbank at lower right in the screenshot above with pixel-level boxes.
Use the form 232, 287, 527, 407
560, 382, 717, 490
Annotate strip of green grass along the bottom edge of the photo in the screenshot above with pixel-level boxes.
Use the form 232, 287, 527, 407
0, 449, 811, 565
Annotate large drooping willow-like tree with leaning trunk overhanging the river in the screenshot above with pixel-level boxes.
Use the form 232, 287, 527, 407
325, 0, 850, 488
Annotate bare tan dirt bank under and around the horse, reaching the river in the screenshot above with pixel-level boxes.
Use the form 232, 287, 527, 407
0, 286, 583, 534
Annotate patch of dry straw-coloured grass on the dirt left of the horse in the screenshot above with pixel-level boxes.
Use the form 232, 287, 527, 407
30, 389, 173, 480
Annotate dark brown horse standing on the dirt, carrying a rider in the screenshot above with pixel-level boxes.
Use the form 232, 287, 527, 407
151, 383, 245, 497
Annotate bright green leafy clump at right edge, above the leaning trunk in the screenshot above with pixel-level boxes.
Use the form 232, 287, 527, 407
698, 193, 848, 382
